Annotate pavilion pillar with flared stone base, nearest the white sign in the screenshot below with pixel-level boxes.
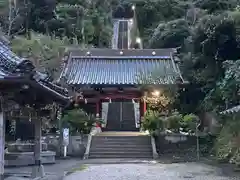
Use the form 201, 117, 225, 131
32, 118, 45, 178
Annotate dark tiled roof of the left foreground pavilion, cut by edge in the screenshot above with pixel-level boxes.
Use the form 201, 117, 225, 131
0, 40, 68, 100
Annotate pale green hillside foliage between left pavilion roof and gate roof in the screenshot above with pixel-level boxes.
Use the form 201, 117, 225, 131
12, 33, 71, 78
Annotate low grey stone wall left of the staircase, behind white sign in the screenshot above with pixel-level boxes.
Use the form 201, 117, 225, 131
43, 134, 88, 158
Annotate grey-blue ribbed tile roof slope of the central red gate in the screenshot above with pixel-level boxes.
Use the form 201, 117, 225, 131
61, 56, 180, 85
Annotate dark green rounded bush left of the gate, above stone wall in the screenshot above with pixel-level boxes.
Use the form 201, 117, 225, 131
61, 109, 96, 134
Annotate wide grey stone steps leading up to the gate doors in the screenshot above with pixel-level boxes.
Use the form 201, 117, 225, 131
88, 132, 153, 159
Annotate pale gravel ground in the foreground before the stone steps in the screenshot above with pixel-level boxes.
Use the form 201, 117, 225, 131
64, 163, 240, 180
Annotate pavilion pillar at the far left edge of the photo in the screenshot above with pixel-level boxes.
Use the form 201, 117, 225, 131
0, 97, 5, 180
